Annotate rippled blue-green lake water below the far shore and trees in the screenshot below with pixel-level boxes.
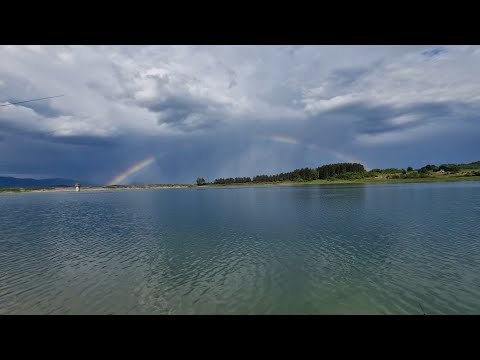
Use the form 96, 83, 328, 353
0, 182, 480, 315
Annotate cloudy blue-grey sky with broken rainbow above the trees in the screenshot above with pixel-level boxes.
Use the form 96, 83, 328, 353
0, 45, 480, 184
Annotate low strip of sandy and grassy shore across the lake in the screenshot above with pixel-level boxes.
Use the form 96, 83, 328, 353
0, 176, 480, 194
